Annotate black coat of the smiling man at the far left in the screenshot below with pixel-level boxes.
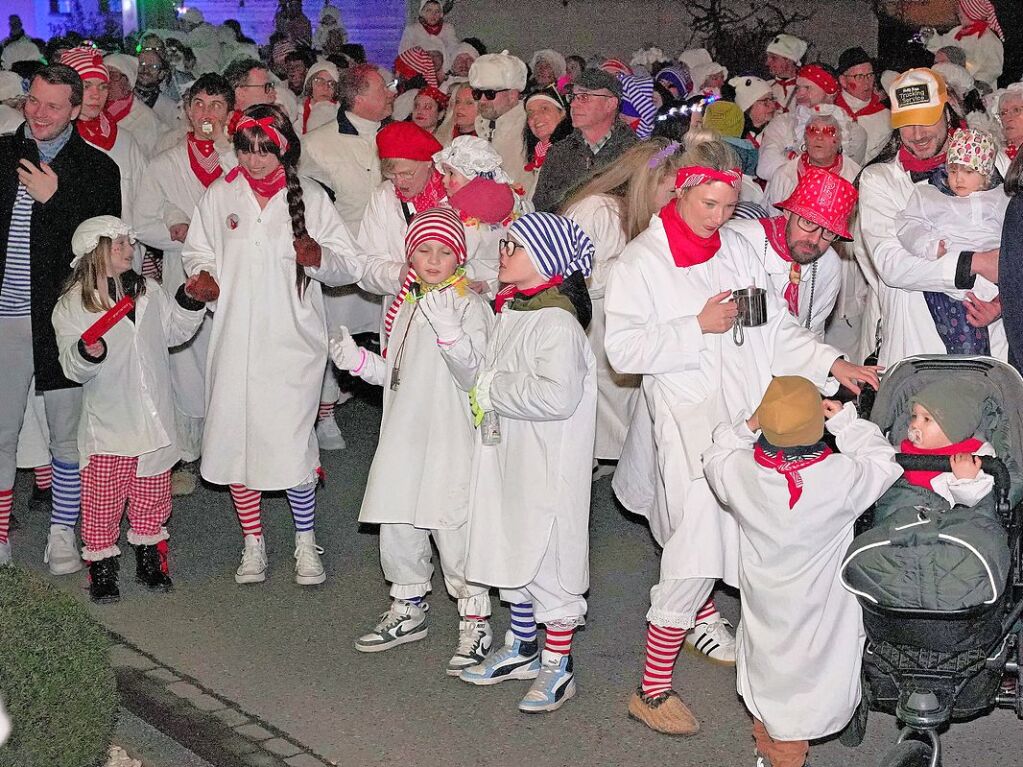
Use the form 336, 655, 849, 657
0, 123, 121, 396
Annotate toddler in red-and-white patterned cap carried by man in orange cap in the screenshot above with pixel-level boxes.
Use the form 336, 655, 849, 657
895, 130, 1009, 359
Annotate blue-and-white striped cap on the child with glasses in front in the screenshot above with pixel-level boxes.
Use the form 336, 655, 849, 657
508, 212, 595, 279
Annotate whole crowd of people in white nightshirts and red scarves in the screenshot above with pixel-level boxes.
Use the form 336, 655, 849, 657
0, 0, 1023, 767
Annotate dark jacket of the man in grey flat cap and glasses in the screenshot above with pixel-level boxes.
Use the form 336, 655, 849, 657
533, 121, 638, 213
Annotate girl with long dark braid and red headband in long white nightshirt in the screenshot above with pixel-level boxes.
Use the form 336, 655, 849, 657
181, 104, 361, 585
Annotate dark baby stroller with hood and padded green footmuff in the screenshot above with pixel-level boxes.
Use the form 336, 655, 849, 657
840, 356, 1023, 767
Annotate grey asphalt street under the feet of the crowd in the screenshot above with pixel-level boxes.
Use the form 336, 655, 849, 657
7, 398, 1023, 767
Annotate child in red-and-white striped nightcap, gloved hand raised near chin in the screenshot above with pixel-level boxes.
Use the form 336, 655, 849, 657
330, 208, 493, 676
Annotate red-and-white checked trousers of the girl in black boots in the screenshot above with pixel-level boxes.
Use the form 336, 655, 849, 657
82, 455, 171, 560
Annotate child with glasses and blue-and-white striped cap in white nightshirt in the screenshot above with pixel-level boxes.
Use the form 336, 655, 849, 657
459, 213, 596, 713
